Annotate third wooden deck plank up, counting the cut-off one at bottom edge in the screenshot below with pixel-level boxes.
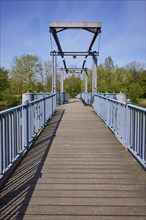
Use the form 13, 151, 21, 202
0, 196, 145, 207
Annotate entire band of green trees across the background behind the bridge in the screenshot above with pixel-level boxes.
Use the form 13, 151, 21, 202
0, 55, 146, 105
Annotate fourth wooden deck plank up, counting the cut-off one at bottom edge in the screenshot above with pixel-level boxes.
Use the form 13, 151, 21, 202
1, 189, 145, 201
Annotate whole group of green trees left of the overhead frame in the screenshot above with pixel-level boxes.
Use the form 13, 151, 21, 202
0, 55, 52, 106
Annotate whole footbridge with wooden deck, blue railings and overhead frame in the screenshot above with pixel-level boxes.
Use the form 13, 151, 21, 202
0, 23, 146, 220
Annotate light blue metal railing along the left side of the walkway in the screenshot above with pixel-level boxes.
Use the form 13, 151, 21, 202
0, 94, 56, 178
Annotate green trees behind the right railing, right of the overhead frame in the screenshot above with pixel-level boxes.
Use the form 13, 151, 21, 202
97, 57, 146, 102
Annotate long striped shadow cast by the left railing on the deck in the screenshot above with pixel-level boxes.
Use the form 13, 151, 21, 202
0, 109, 64, 220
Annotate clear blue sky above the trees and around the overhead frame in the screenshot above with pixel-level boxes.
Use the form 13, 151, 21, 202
0, 0, 146, 68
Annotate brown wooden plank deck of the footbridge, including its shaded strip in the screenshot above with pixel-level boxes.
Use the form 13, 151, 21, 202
0, 100, 146, 220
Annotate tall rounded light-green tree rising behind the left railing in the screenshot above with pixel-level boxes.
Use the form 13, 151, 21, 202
10, 55, 43, 95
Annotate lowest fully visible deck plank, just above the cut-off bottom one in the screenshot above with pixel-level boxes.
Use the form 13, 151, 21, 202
11, 205, 145, 218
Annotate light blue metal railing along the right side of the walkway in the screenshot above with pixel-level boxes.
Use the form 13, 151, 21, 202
94, 94, 146, 168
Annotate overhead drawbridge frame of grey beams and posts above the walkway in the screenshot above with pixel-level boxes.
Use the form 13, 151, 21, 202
49, 22, 101, 94
